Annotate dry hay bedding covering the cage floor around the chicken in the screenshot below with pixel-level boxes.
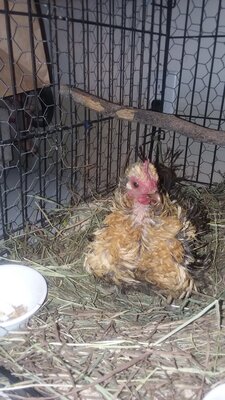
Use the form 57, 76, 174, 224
0, 184, 225, 400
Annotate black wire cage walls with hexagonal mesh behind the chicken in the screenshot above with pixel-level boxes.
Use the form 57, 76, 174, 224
0, 0, 225, 241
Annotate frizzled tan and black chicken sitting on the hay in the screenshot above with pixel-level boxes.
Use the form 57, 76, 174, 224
84, 160, 196, 301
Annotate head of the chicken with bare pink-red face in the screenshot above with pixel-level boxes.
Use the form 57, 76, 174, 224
126, 160, 160, 205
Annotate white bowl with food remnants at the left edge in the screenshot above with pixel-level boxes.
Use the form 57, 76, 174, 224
0, 264, 48, 336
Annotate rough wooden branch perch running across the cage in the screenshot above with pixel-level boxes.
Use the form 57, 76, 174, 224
60, 85, 225, 146
